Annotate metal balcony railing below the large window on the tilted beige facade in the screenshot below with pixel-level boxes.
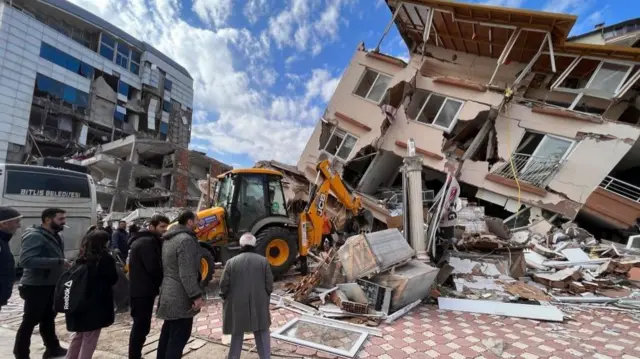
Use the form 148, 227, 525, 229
492, 153, 563, 188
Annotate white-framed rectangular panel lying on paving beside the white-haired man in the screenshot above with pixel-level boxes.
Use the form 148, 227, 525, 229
271, 318, 369, 358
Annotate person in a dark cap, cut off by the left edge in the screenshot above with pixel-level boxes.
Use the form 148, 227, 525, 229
0, 207, 22, 310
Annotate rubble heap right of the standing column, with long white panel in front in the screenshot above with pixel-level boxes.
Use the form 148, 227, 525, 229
431, 204, 640, 321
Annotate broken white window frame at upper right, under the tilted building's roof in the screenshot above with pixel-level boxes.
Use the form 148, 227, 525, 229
550, 53, 637, 112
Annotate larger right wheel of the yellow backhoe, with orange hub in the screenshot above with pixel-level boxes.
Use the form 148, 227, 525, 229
256, 227, 298, 278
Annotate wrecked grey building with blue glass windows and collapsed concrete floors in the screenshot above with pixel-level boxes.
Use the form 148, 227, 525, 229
0, 0, 231, 211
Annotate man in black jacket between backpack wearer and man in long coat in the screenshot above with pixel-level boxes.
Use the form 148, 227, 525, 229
129, 214, 169, 359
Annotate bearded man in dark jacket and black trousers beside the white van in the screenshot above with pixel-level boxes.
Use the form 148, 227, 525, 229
13, 208, 71, 359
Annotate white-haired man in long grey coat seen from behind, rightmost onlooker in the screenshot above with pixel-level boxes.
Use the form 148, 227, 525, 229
220, 233, 273, 359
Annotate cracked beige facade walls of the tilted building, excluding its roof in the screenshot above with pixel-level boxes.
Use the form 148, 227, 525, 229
297, 22, 640, 219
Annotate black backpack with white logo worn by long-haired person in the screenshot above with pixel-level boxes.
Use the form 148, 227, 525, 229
53, 262, 89, 313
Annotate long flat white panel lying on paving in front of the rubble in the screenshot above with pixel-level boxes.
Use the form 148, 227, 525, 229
438, 297, 564, 322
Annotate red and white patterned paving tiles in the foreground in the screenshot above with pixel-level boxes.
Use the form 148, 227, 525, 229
0, 286, 640, 359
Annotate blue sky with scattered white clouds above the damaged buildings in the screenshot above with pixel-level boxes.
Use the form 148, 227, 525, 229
71, 0, 640, 167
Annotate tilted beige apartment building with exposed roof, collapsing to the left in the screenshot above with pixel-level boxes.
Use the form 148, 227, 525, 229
297, 0, 640, 240
